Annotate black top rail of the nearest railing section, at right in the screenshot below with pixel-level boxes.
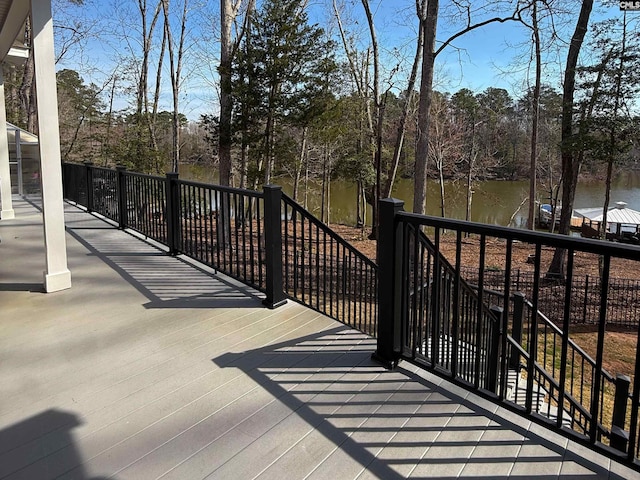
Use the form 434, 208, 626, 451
398, 212, 640, 260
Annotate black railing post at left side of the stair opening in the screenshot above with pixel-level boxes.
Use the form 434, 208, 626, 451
262, 185, 287, 308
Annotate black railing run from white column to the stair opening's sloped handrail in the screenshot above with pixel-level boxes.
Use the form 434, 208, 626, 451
63, 163, 377, 324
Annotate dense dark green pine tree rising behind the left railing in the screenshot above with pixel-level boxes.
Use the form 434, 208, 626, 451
234, 0, 335, 184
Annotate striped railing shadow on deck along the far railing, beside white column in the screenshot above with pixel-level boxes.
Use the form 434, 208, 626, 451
66, 206, 261, 308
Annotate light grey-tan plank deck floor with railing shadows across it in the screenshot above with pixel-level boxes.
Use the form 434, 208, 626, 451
0, 199, 640, 480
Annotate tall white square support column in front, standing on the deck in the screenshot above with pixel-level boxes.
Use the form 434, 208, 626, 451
31, 0, 71, 292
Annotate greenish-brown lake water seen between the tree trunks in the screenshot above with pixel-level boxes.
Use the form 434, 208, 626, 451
180, 165, 640, 227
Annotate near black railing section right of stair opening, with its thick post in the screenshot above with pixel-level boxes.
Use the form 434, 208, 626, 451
375, 199, 640, 463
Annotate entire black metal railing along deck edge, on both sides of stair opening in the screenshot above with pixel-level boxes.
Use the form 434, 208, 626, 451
63, 164, 640, 466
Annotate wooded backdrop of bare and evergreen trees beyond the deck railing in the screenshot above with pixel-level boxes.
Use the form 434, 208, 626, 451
3, 0, 640, 235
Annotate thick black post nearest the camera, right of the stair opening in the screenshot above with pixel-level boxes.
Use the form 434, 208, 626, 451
372, 198, 404, 369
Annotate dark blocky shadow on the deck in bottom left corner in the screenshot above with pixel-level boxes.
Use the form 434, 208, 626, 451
0, 409, 106, 480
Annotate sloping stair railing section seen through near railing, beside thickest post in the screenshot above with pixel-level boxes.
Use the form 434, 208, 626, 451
400, 223, 500, 392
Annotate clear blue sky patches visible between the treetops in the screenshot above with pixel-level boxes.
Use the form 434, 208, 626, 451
54, 0, 640, 120
